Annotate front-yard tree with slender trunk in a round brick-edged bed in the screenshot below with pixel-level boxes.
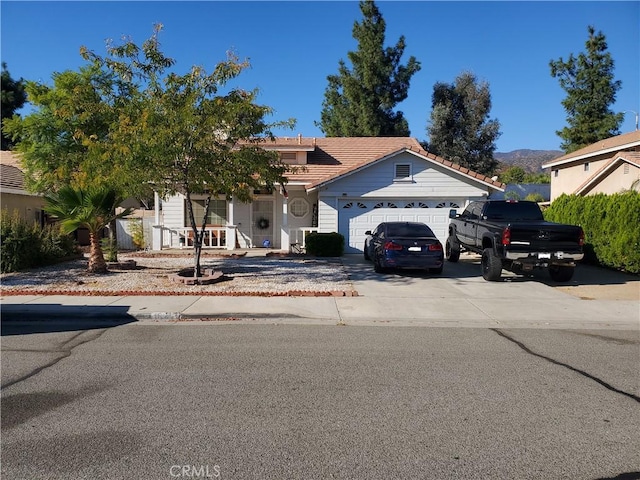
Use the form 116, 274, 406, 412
83, 25, 294, 277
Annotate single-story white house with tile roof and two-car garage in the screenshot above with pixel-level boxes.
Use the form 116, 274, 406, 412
152, 136, 504, 253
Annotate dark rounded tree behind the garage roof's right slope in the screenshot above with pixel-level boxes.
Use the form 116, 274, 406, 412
427, 72, 501, 175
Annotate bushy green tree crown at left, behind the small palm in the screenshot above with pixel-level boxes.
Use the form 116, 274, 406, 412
5, 65, 151, 197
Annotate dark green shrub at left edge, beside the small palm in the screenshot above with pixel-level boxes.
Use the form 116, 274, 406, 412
0, 209, 76, 273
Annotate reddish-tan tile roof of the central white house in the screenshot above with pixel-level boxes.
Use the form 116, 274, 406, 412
280, 137, 505, 189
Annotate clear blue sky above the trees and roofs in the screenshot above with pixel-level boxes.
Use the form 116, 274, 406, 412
0, 0, 640, 152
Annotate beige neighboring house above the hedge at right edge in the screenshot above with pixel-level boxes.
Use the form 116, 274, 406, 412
542, 130, 640, 201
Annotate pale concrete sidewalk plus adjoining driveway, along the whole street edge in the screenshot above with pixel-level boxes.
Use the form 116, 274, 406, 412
1, 255, 640, 330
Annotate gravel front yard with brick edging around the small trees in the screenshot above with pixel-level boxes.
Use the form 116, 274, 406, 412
0, 254, 355, 296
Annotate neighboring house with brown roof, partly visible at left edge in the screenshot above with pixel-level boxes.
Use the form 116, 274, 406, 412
0, 150, 44, 224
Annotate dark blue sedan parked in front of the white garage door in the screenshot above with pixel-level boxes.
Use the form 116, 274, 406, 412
364, 222, 444, 273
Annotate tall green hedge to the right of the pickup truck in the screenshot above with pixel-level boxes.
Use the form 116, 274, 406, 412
544, 191, 640, 273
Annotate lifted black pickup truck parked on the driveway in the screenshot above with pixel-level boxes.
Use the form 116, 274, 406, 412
445, 200, 584, 282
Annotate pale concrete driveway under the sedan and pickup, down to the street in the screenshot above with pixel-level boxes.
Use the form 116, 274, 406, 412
336, 255, 640, 329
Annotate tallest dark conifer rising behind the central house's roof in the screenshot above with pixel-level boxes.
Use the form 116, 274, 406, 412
316, 0, 420, 137
